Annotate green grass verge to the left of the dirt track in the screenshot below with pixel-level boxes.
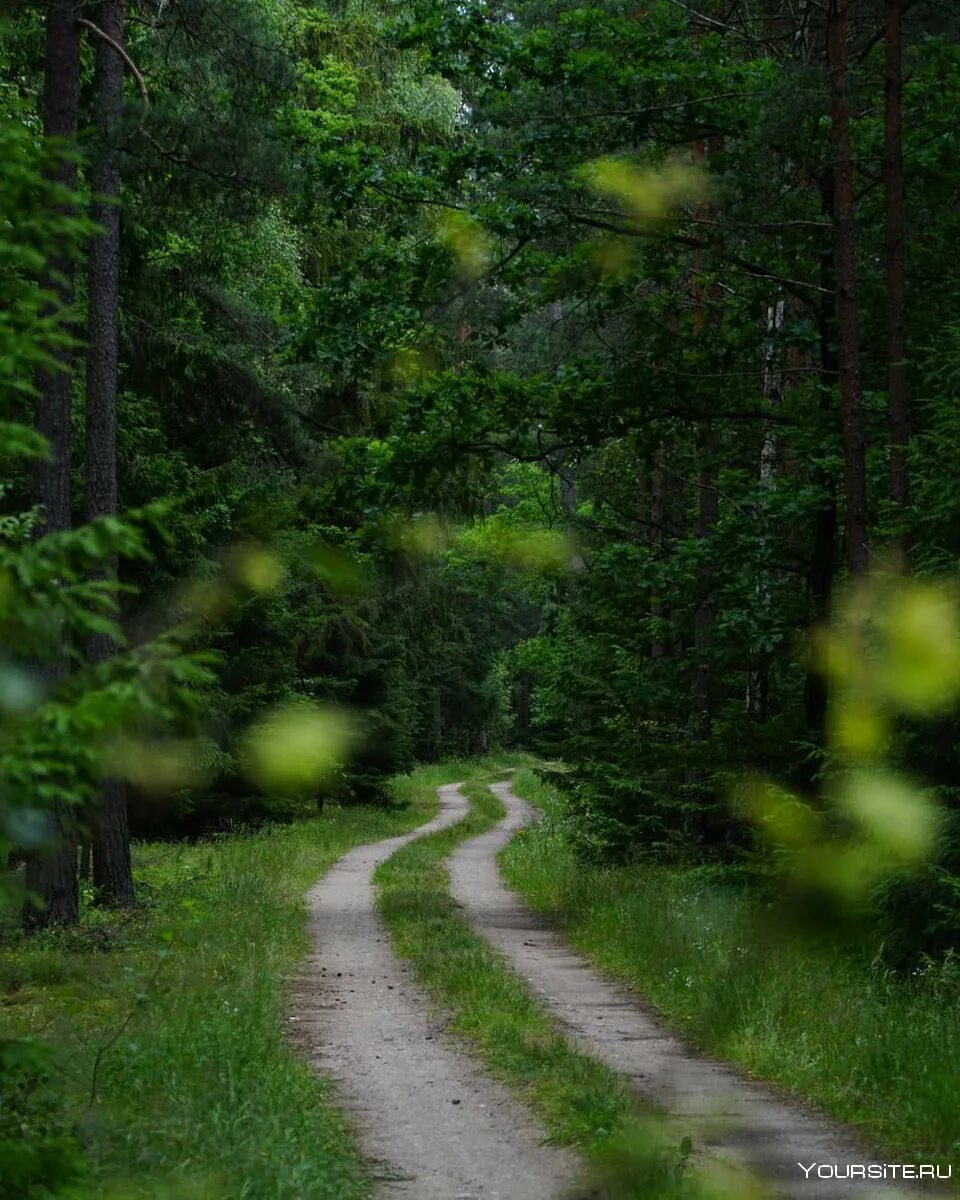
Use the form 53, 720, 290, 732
0, 790, 436, 1200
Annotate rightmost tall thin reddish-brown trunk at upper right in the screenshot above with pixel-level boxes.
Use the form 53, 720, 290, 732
884, 0, 911, 525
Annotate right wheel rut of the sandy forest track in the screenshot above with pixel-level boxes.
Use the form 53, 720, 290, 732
449, 782, 920, 1200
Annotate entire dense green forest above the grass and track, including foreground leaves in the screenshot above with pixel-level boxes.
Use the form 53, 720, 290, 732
0, 0, 960, 1195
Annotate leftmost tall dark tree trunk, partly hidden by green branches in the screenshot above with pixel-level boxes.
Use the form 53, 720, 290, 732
23, 0, 80, 929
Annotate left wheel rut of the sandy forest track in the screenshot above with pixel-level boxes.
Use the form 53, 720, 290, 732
290, 785, 578, 1200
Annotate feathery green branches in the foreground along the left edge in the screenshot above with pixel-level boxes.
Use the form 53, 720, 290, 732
0, 114, 209, 907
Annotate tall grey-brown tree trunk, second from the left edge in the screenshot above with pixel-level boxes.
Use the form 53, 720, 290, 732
86, 0, 133, 905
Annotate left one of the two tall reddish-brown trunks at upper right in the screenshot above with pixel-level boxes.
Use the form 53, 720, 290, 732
827, 0, 870, 575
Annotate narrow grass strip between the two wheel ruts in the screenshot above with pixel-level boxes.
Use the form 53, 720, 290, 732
374, 760, 758, 1200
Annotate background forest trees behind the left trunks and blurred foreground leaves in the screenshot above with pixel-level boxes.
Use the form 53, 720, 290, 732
7, 0, 960, 919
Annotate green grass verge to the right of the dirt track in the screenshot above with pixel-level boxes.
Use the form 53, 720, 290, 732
500, 770, 960, 1163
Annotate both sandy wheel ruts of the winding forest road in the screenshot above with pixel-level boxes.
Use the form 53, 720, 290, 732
290, 784, 919, 1200
